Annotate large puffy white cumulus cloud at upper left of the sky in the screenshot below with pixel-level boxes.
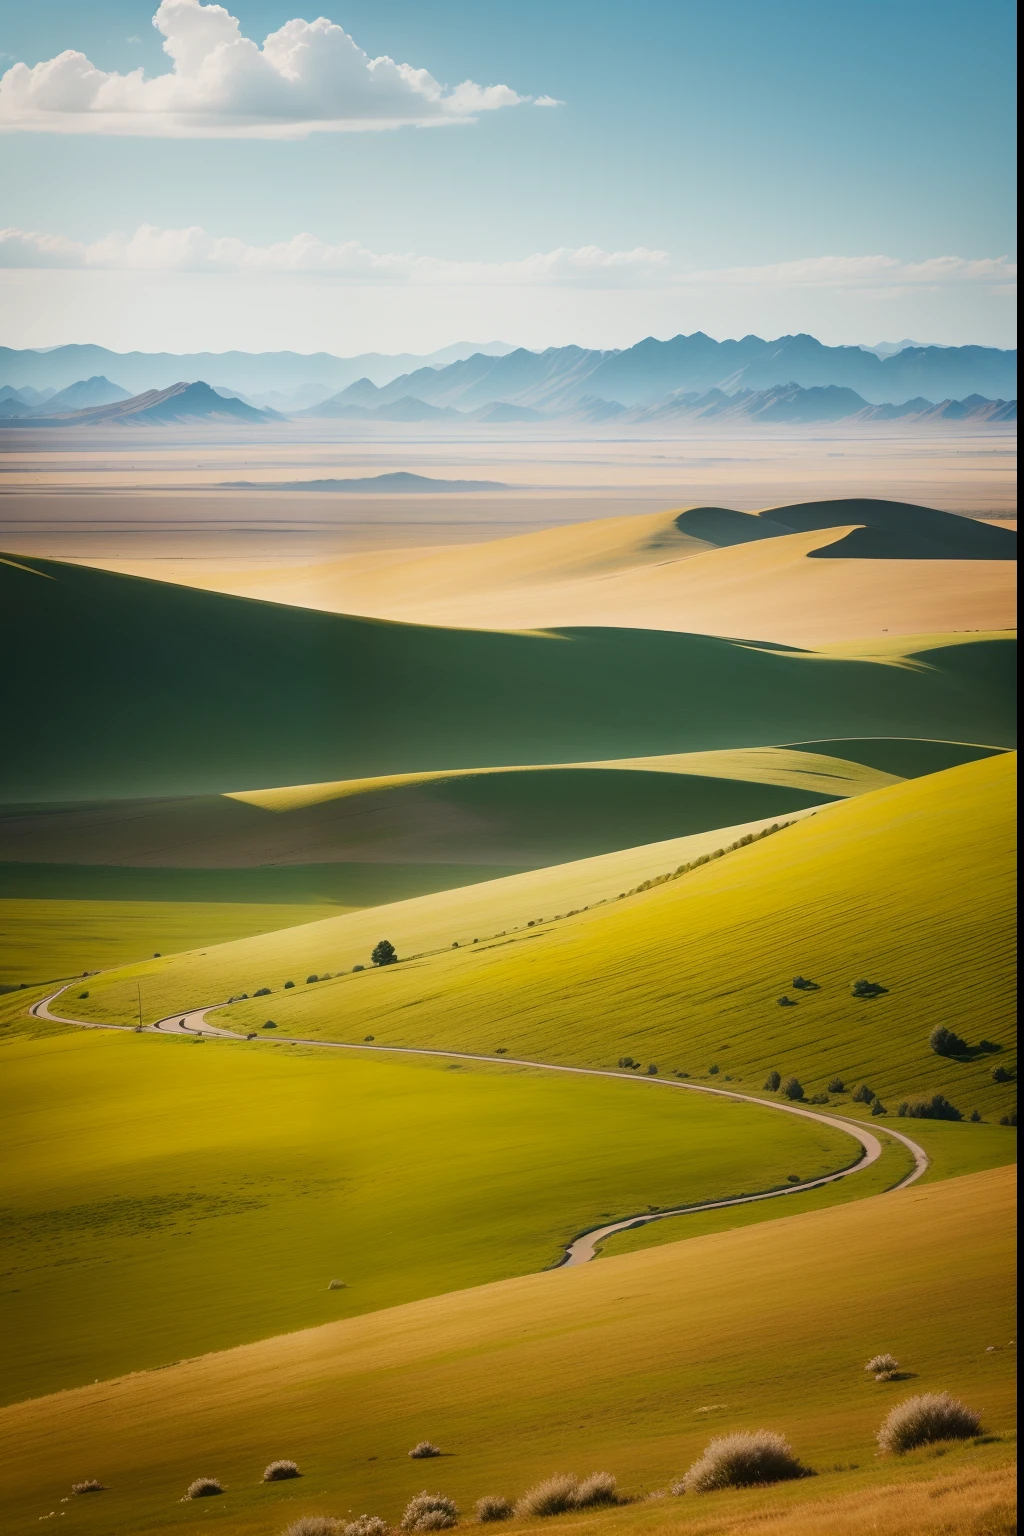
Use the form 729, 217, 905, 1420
0, 0, 534, 138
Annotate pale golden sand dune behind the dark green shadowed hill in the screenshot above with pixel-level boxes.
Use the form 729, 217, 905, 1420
82, 507, 1015, 645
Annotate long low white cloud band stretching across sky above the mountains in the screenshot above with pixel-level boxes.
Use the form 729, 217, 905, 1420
0, 224, 1016, 298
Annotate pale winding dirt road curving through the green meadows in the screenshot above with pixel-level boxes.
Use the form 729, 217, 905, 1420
29, 982, 929, 1269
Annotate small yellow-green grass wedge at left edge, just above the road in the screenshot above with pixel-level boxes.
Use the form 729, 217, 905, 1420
0, 899, 338, 986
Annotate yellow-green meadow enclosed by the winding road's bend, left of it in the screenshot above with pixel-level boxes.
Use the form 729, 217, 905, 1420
0, 1031, 859, 1401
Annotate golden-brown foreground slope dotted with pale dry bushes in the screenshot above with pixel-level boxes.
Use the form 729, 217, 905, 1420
0, 1170, 1015, 1536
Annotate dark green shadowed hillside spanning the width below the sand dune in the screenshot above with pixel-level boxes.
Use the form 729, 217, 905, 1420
0, 552, 1012, 803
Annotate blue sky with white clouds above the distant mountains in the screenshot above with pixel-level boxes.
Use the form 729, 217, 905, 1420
0, 0, 1016, 353
